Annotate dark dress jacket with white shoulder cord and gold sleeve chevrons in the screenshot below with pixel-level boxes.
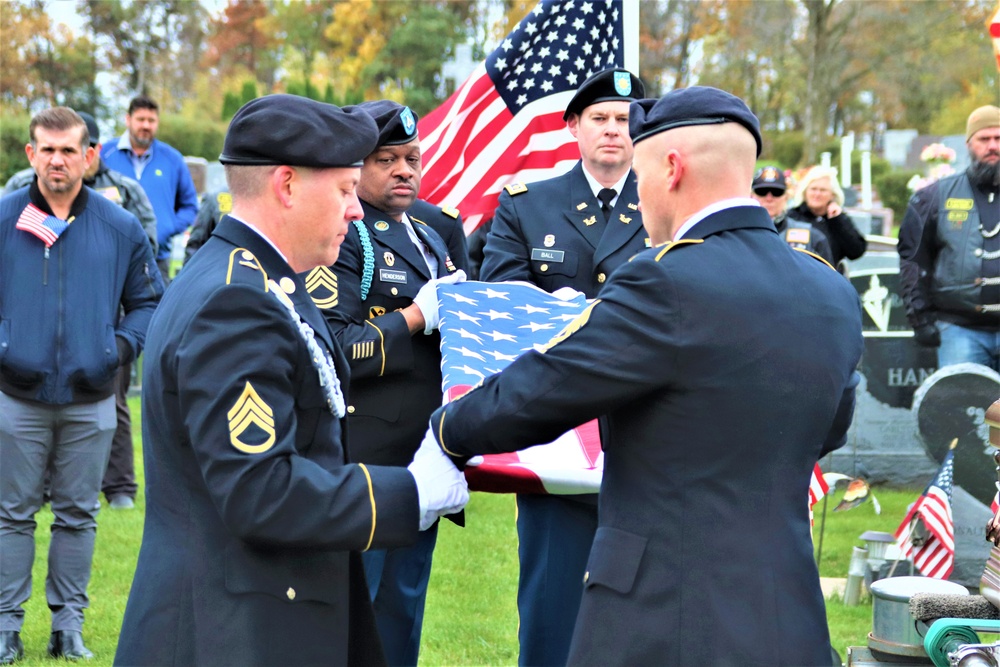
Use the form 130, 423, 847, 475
115, 217, 419, 667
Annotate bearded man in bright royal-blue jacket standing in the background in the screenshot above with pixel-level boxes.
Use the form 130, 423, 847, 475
101, 95, 198, 282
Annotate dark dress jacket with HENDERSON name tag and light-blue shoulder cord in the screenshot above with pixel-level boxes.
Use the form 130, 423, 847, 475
305, 201, 457, 466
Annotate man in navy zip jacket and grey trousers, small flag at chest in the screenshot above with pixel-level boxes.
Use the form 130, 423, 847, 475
0, 107, 163, 664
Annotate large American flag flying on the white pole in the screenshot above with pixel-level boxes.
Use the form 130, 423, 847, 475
418, 0, 639, 234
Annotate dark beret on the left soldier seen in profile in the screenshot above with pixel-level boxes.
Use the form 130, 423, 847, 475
219, 95, 378, 169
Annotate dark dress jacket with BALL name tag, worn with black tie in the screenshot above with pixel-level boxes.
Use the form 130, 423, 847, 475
479, 162, 649, 299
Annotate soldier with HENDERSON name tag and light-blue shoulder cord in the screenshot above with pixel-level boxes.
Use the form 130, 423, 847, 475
304, 100, 465, 665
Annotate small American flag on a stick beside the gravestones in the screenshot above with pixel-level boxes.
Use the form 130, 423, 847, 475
896, 443, 955, 579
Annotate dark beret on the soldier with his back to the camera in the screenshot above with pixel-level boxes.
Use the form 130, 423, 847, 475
628, 86, 761, 156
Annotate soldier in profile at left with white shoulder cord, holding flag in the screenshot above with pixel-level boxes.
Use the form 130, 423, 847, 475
115, 95, 467, 666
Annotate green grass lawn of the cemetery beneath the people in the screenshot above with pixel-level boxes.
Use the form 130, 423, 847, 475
18, 399, 919, 666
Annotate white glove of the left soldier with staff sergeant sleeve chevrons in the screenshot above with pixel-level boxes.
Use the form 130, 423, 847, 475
407, 428, 469, 530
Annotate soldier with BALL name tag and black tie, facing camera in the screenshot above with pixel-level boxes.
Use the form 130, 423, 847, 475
480, 69, 649, 667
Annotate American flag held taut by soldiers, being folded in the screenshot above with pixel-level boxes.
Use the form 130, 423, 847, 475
438, 281, 604, 494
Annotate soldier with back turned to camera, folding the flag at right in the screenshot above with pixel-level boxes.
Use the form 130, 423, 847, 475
429, 87, 864, 667
